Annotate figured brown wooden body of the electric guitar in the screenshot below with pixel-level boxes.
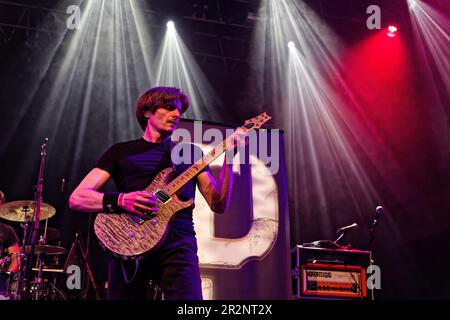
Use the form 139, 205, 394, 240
94, 168, 194, 259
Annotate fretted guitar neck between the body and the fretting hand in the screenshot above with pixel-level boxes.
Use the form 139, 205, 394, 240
164, 134, 234, 195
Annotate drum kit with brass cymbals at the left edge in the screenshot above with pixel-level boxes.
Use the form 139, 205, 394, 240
0, 200, 67, 300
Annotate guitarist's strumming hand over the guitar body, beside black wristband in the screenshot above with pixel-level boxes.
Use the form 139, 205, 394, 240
119, 191, 158, 218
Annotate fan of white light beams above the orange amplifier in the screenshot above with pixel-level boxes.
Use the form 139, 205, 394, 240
252, 0, 390, 238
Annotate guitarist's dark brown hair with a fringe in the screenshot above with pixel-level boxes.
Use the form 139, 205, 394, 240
136, 87, 189, 130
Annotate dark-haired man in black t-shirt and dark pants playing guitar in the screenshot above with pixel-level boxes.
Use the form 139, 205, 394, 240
69, 87, 238, 300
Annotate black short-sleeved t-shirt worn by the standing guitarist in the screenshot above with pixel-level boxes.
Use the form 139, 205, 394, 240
95, 138, 210, 232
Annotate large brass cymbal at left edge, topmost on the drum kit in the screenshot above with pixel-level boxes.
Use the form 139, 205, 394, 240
0, 200, 56, 222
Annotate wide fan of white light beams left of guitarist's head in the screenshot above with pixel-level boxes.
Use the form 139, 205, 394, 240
0, 0, 161, 194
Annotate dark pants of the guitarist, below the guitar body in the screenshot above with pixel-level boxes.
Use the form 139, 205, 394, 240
108, 228, 202, 300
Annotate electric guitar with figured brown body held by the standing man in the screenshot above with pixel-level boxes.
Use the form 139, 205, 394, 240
94, 112, 272, 259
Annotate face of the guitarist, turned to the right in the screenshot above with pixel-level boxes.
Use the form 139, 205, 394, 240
147, 100, 181, 134
